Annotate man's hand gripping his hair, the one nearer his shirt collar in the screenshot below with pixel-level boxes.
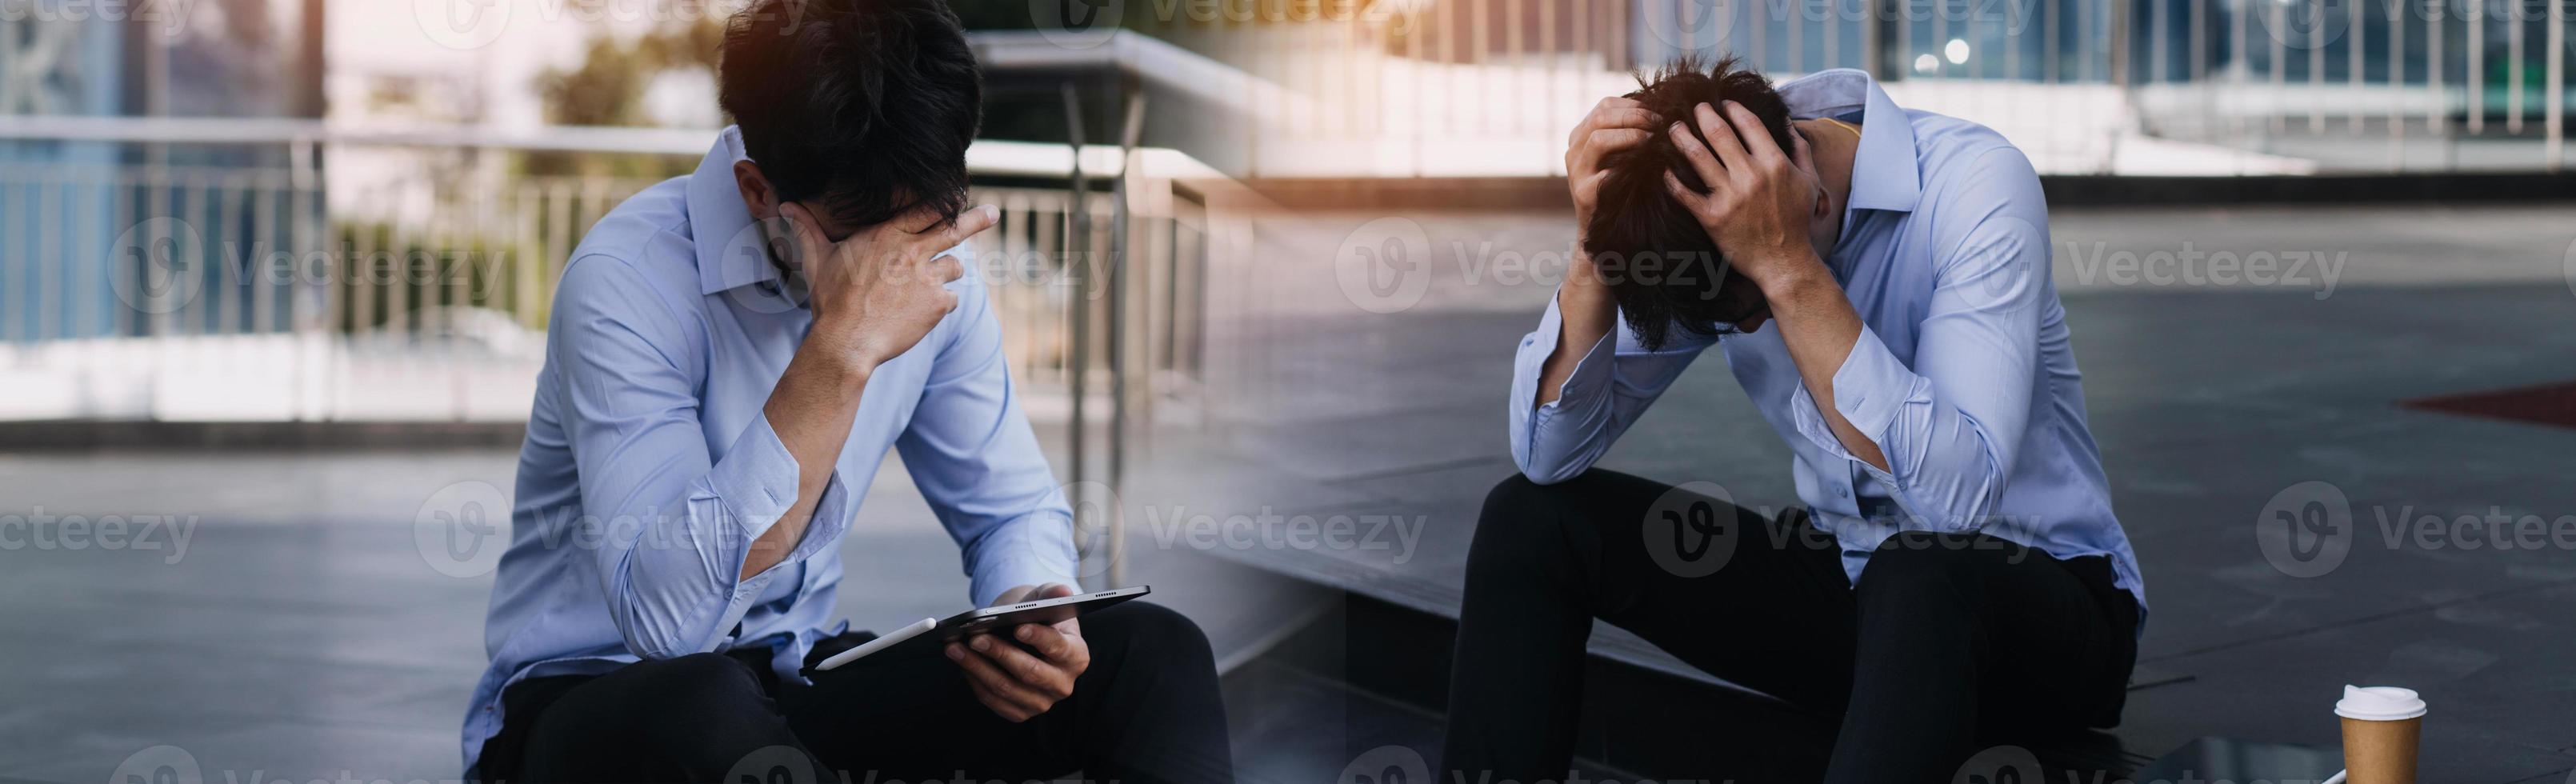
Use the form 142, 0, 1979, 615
1664, 101, 1824, 291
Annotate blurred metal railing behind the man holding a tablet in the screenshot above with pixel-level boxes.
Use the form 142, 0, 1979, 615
0, 116, 1216, 428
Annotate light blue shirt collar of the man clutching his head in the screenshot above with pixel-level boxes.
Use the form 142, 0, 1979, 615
1778, 67, 1922, 214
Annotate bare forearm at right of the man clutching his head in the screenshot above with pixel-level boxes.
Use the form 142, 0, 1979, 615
1762, 255, 1888, 470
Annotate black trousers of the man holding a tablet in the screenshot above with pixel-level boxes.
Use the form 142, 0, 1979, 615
482, 601, 1234, 784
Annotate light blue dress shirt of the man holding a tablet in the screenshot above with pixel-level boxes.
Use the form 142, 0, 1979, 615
464, 129, 1074, 774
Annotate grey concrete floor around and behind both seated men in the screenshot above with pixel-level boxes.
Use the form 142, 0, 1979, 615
0, 206, 2576, 784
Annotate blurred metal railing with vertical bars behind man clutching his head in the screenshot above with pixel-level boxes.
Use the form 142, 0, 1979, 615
1224, 0, 2571, 178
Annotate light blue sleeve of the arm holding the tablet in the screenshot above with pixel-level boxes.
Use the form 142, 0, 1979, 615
894, 276, 1079, 606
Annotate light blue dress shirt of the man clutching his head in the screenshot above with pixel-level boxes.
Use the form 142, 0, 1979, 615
1510, 70, 2146, 618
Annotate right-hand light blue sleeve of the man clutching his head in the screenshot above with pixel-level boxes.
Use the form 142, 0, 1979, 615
1790, 147, 2056, 531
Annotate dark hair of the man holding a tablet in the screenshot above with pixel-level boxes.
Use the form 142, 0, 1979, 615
716, 0, 984, 227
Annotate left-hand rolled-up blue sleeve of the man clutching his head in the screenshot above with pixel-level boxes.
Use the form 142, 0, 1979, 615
1510, 297, 1716, 485
